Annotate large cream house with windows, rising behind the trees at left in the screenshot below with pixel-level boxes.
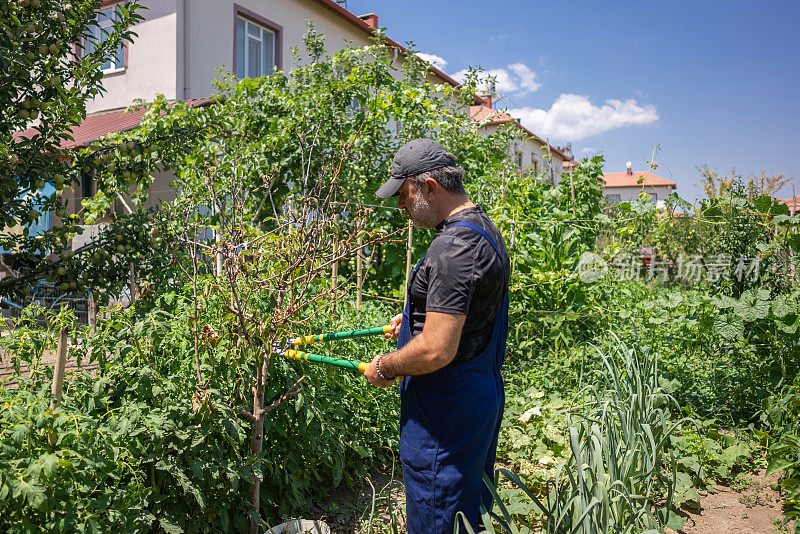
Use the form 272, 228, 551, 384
87, 0, 458, 113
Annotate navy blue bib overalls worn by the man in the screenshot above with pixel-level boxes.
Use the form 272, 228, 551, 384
397, 221, 508, 534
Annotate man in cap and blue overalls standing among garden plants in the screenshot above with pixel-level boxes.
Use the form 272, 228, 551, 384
364, 139, 510, 534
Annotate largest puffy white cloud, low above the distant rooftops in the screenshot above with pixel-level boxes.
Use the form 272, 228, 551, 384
509, 93, 659, 141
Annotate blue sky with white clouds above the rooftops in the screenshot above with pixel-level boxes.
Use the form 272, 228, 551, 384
347, 0, 800, 199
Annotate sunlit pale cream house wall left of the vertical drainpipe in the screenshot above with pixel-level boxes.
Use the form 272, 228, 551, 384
86, 0, 181, 113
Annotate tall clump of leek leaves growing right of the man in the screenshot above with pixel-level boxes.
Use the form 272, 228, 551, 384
466, 334, 683, 534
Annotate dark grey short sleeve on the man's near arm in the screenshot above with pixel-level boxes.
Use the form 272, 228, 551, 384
425, 235, 475, 315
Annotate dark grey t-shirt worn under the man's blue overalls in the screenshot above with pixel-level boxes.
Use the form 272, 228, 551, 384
410, 206, 511, 362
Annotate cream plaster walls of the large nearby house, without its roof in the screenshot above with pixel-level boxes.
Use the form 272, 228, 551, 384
87, 0, 450, 113
